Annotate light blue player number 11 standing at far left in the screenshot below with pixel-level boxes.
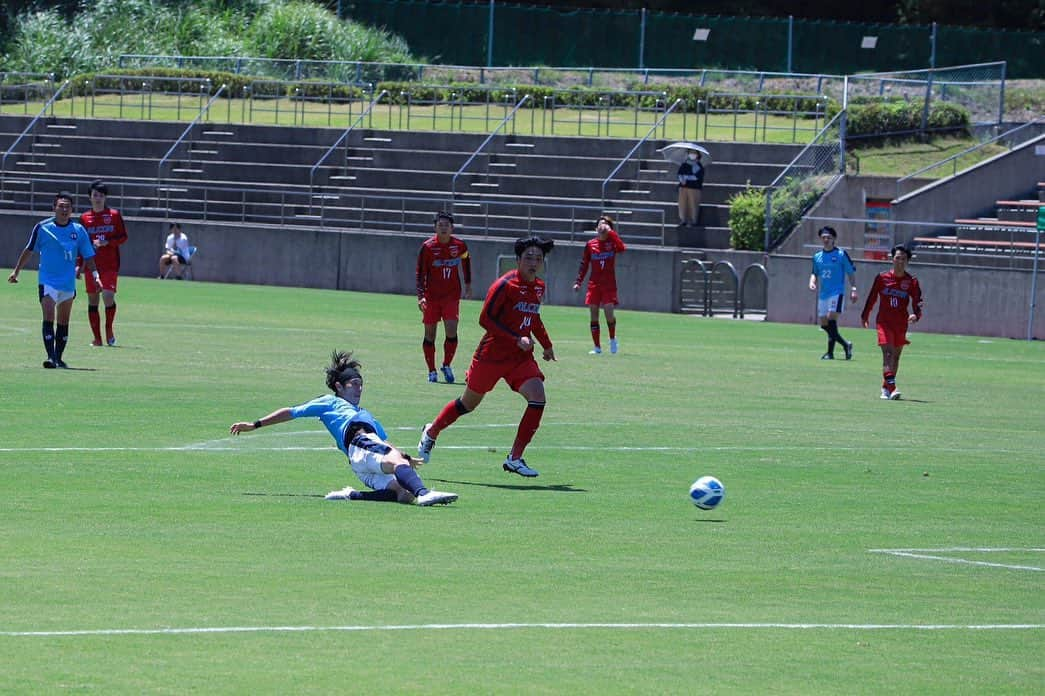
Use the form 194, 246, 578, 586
7, 191, 100, 369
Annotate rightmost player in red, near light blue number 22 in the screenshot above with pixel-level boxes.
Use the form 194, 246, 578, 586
861, 245, 922, 399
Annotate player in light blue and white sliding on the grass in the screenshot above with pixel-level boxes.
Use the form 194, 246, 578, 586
229, 351, 458, 507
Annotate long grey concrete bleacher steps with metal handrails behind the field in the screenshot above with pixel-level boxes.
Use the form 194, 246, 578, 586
0, 117, 800, 249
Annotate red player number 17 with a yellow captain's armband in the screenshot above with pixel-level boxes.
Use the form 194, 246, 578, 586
417, 212, 471, 384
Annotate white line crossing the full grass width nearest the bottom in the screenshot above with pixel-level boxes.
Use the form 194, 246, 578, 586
0, 623, 1045, 637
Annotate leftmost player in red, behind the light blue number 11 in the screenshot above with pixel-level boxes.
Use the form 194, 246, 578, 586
76, 181, 127, 346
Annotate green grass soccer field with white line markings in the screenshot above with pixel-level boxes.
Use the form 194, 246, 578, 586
0, 270, 1045, 695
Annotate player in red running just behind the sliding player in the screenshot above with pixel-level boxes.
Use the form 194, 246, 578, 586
417, 237, 555, 478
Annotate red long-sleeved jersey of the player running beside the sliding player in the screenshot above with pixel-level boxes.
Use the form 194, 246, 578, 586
475, 271, 552, 362
